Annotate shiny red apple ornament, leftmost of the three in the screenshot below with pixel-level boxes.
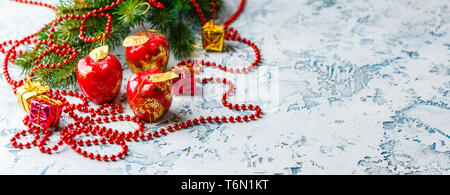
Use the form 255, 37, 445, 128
77, 46, 123, 104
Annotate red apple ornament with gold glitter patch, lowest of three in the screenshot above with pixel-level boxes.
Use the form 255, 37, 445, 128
127, 69, 176, 122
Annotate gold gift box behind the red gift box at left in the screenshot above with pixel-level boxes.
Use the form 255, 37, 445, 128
16, 78, 50, 113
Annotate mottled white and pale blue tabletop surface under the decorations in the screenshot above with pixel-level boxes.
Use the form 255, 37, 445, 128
0, 0, 450, 174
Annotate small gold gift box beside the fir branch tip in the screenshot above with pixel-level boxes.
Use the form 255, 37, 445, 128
202, 20, 225, 52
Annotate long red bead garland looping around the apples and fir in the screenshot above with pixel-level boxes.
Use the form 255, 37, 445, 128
0, 0, 262, 161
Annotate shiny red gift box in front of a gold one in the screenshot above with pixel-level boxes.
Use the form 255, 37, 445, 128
30, 95, 63, 128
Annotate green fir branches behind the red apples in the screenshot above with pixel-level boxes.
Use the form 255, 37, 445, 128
16, 0, 223, 88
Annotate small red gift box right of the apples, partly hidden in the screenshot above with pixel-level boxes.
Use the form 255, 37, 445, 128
172, 63, 200, 96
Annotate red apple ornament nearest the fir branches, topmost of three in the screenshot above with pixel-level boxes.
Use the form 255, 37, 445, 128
123, 32, 170, 73
